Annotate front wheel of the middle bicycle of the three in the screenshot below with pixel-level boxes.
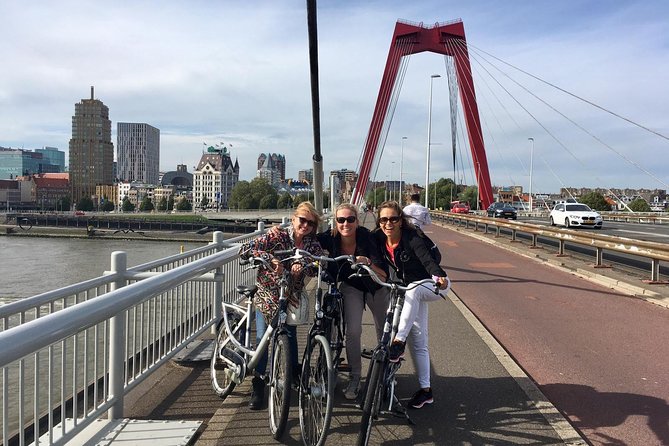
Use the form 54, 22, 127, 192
300, 335, 336, 446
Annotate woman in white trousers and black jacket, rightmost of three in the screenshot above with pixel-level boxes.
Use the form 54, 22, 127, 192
375, 201, 451, 409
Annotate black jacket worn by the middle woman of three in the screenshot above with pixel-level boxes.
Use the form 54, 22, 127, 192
317, 226, 388, 293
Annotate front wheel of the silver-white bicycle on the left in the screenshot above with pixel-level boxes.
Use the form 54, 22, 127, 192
269, 334, 293, 440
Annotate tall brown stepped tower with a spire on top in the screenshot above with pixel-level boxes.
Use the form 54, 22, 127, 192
69, 87, 114, 204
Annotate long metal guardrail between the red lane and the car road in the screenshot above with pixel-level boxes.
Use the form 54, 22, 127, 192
430, 211, 669, 283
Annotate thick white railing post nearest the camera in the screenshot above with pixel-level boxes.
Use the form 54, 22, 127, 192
107, 251, 128, 420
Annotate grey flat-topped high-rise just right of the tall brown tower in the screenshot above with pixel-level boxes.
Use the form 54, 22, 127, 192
116, 122, 160, 184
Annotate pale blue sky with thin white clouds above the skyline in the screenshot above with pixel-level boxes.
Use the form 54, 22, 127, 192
0, 0, 669, 192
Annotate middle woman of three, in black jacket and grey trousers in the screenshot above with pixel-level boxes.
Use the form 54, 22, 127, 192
317, 203, 388, 400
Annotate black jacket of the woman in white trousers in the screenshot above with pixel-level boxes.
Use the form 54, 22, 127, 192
374, 228, 447, 284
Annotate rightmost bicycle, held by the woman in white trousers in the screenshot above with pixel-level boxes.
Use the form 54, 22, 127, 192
348, 264, 439, 446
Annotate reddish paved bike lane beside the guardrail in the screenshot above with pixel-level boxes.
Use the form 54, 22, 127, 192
426, 225, 669, 445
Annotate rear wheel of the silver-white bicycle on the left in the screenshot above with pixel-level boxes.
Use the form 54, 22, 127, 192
209, 316, 246, 399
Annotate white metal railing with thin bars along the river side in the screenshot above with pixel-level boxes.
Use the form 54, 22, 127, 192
0, 223, 274, 446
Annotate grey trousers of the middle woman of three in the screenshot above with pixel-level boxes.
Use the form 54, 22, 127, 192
339, 283, 389, 376
